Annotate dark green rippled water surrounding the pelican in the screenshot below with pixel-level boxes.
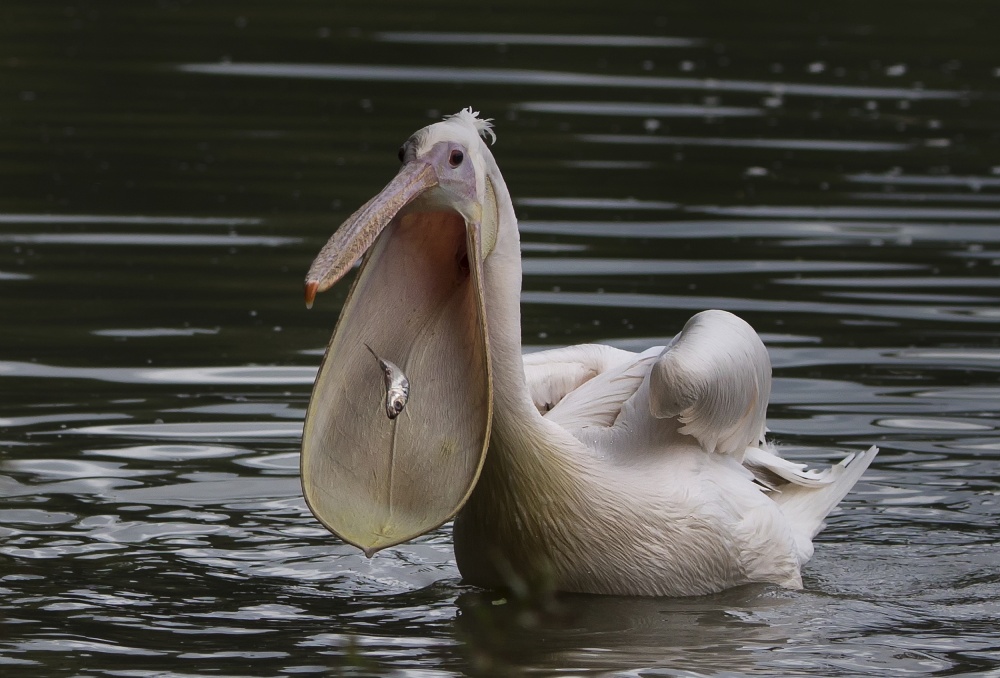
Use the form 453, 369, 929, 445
0, 0, 1000, 676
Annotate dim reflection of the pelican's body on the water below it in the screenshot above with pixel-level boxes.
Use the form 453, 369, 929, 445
455, 585, 796, 675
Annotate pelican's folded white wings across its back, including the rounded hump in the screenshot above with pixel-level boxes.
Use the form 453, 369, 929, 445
524, 311, 772, 462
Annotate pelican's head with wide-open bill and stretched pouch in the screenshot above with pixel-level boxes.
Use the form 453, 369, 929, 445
302, 109, 504, 556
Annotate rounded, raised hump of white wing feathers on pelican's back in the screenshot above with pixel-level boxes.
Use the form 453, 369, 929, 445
649, 311, 771, 461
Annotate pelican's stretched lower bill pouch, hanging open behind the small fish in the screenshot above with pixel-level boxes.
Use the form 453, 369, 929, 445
301, 211, 491, 556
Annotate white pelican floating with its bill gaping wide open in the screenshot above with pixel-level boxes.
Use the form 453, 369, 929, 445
301, 108, 878, 596
